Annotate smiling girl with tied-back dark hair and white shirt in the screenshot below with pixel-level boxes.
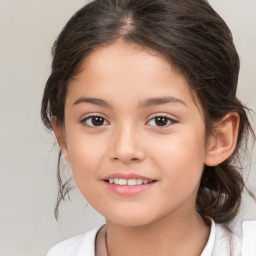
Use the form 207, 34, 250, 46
42, 0, 256, 256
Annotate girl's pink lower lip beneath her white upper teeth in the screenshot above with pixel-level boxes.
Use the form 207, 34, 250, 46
105, 181, 156, 196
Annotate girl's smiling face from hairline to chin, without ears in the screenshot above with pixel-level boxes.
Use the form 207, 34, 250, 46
58, 41, 210, 226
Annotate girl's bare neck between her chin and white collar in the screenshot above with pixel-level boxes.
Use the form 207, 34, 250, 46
106, 212, 209, 256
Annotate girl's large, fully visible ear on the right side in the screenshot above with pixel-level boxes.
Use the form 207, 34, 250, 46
205, 112, 240, 166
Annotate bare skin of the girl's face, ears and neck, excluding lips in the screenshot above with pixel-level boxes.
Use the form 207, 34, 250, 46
53, 41, 239, 256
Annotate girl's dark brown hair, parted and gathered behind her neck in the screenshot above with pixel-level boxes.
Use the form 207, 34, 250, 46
41, 0, 254, 223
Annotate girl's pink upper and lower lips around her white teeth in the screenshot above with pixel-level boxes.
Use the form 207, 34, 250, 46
103, 172, 156, 196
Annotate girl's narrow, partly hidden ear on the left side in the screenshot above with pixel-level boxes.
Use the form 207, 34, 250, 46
52, 116, 70, 163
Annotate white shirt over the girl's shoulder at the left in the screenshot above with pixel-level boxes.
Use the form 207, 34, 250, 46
47, 226, 101, 256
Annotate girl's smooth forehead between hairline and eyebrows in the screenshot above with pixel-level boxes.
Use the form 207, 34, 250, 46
69, 41, 202, 112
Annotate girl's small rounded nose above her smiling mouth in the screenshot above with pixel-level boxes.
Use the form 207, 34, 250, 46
110, 125, 145, 164
